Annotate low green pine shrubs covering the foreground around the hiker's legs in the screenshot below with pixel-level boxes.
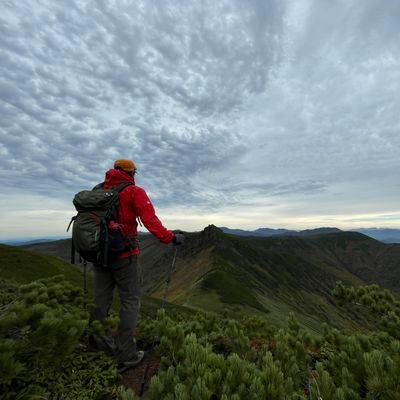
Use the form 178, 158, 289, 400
0, 276, 400, 400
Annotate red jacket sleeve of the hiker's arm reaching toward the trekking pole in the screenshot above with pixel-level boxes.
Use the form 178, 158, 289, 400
133, 186, 174, 243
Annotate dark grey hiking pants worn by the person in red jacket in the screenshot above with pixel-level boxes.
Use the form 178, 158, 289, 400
91, 256, 142, 363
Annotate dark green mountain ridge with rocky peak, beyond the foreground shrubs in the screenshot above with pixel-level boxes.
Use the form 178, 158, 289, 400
14, 225, 400, 330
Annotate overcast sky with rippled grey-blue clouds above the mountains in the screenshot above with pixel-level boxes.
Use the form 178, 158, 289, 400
0, 0, 400, 239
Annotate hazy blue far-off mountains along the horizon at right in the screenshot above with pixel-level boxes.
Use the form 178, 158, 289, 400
220, 227, 400, 243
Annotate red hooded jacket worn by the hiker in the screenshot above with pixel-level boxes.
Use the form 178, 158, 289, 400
103, 169, 174, 258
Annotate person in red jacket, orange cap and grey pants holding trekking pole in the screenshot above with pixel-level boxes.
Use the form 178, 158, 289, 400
91, 160, 184, 372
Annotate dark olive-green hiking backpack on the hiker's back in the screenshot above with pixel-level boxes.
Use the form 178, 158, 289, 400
67, 182, 136, 267
